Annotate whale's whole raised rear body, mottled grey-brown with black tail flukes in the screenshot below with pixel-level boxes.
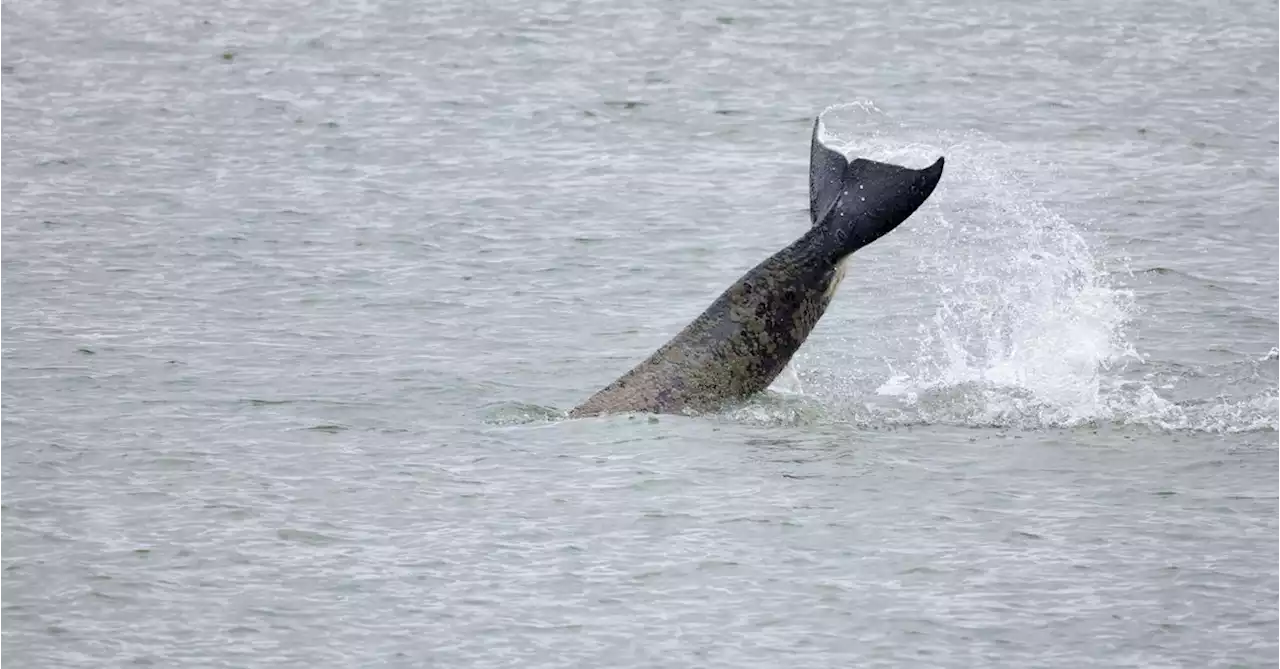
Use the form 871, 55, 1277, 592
570, 116, 943, 417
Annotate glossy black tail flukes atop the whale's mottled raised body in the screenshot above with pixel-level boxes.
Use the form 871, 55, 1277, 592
809, 115, 945, 256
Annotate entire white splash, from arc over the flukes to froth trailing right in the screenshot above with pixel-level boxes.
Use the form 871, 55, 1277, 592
778, 102, 1280, 432
